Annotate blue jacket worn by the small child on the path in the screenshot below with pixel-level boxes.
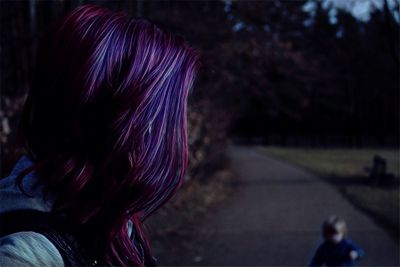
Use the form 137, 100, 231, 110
309, 239, 365, 266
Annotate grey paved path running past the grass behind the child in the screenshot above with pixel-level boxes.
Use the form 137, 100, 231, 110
152, 146, 399, 266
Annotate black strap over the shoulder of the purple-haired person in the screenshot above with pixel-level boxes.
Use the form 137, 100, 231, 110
0, 213, 97, 266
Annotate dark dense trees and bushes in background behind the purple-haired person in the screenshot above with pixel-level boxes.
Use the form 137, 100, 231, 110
0, 0, 399, 175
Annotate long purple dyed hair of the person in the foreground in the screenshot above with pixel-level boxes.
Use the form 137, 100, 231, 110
18, 5, 199, 266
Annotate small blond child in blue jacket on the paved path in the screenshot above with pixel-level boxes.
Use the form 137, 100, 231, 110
309, 216, 364, 266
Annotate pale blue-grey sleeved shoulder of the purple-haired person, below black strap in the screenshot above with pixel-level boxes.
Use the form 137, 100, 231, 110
0, 231, 64, 267
